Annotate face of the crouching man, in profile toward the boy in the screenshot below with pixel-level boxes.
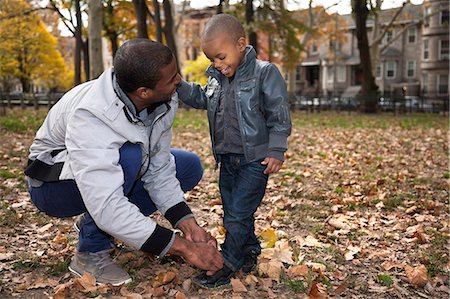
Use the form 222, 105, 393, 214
151, 58, 181, 103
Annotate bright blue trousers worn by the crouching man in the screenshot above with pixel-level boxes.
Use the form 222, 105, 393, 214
30, 143, 203, 252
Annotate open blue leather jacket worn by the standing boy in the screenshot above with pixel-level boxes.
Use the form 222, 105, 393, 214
177, 46, 292, 164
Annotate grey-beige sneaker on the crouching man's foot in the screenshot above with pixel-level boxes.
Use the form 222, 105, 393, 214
69, 249, 132, 286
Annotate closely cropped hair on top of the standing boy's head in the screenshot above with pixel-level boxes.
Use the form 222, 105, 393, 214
202, 14, 245, 41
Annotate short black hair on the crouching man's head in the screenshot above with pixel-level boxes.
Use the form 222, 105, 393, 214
113, 38, 174, 92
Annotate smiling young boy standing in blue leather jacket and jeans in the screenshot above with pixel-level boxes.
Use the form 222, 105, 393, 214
177, 14, 291, 288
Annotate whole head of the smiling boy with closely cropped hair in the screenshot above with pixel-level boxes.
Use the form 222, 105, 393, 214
201, 14, 247, 77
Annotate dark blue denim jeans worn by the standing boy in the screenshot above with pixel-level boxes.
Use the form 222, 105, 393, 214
219, 154, 268, 272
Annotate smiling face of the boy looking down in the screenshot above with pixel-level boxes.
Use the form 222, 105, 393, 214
202, 33, 246, 78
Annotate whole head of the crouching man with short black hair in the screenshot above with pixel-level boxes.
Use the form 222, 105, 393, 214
114, 39, 180, 108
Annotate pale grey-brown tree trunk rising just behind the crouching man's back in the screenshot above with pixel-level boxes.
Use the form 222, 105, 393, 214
88, 0, 104, 79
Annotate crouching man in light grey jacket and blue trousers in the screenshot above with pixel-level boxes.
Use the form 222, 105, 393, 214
25, 39, 223, 286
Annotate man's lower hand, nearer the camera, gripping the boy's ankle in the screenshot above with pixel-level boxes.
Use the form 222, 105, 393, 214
169, 236, 223, 275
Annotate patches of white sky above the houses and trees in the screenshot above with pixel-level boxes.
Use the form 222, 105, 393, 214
175, 0, 423, 14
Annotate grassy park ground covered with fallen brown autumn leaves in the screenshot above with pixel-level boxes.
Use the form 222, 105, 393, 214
0, 110, 450, 298
